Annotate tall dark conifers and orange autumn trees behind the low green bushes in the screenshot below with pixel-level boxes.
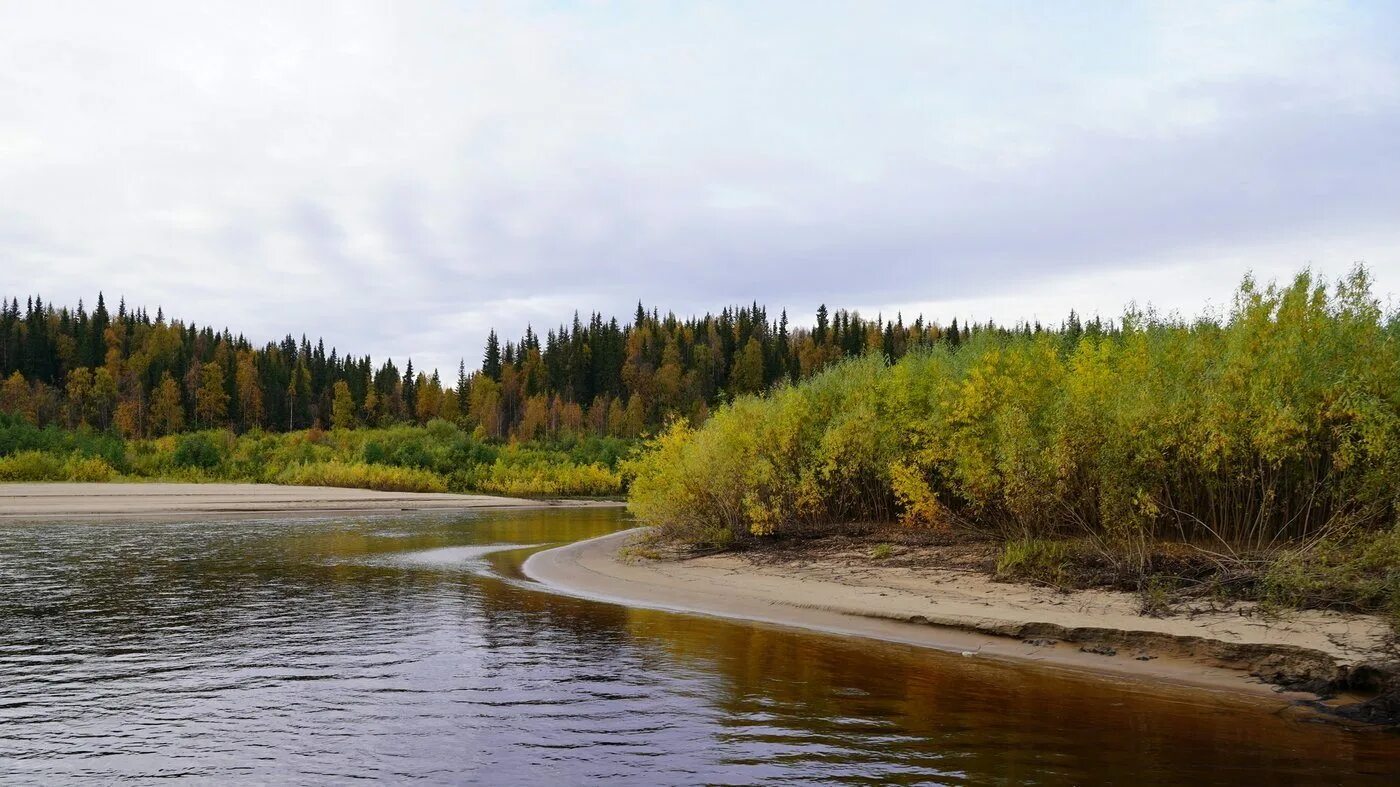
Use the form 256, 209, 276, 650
0, 295, 1080, 440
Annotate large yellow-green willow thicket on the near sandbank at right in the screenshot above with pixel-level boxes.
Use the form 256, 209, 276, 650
629, 267, 1400, 548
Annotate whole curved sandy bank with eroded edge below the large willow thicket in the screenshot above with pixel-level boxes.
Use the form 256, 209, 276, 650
524, 532, 1400, 724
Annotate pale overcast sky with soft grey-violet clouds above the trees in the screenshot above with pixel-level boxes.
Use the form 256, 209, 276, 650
0, 0, 1400, 371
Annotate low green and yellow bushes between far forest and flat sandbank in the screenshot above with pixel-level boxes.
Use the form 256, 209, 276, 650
0, 415, 630, 497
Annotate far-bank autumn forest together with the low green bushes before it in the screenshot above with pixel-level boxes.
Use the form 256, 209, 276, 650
0, 288, 1030, 496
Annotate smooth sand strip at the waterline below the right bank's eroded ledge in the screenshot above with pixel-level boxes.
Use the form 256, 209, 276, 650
521, 528, 1389, 725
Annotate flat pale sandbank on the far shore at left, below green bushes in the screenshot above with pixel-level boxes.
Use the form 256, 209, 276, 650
0, 483, 619, 520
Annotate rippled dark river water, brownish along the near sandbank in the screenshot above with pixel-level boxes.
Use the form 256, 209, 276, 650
0, 510, 1400, 784
